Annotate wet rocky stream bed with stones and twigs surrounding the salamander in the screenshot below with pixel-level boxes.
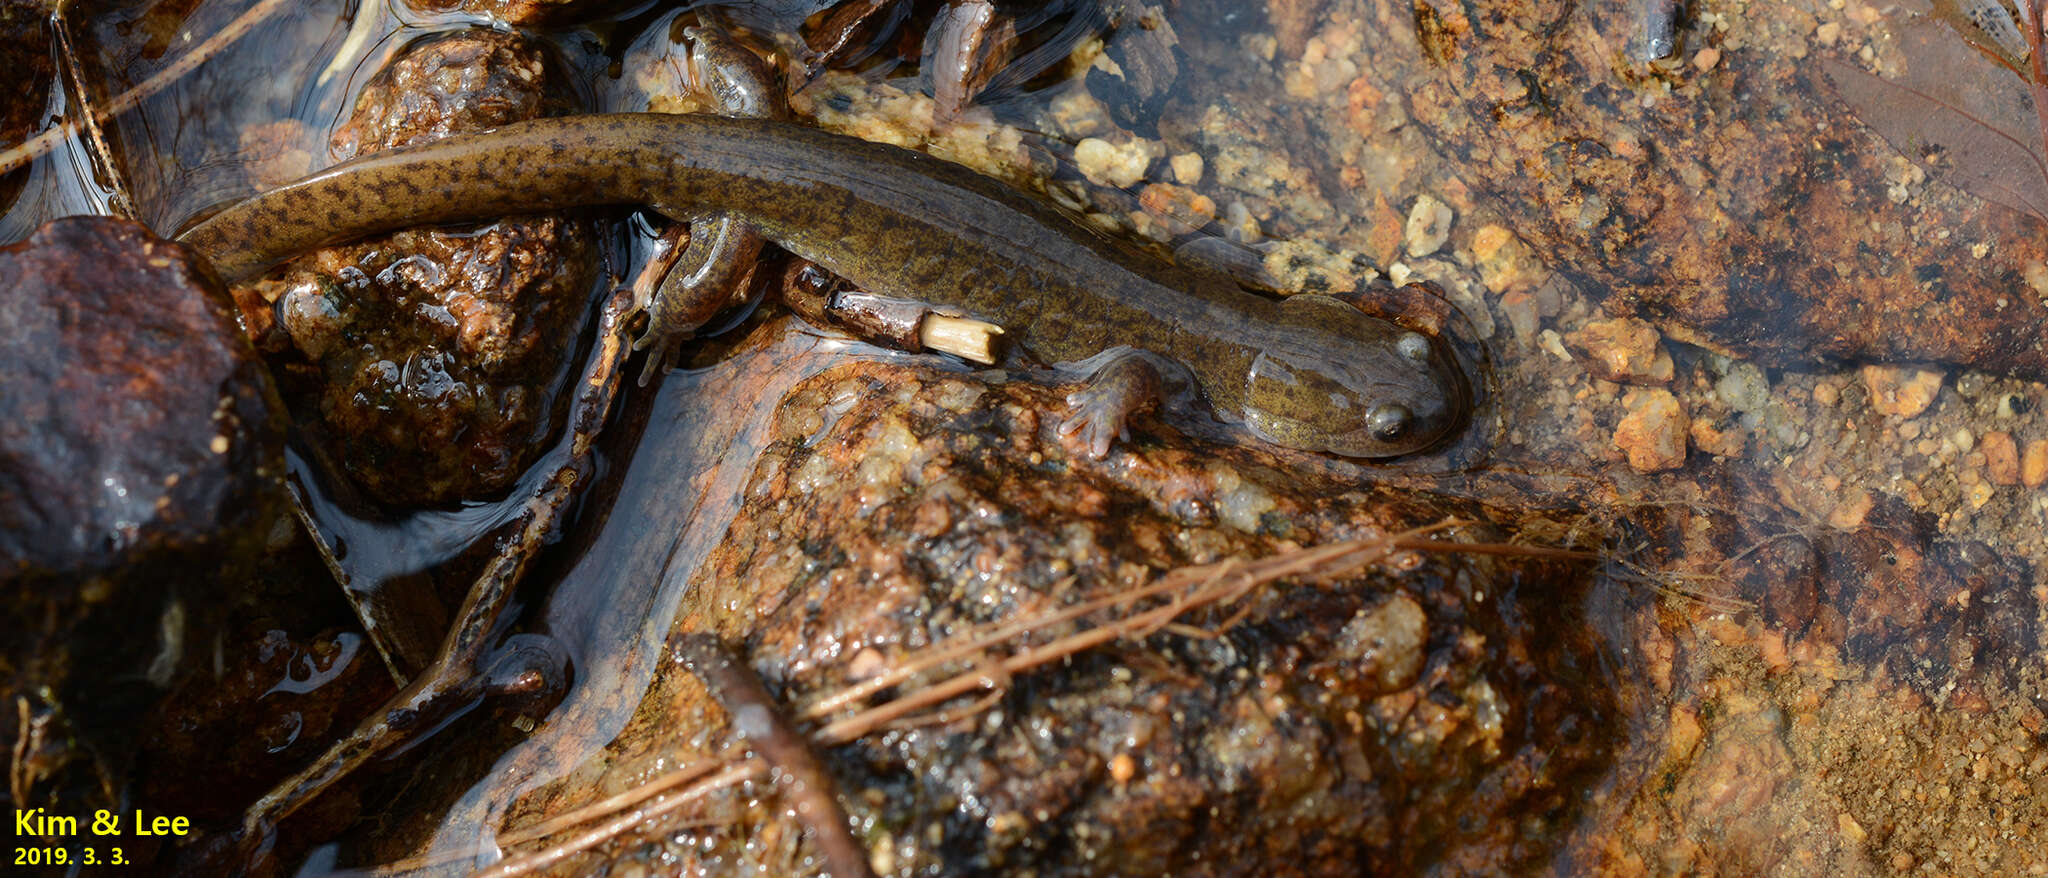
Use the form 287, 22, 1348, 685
0, 0, 2048, 876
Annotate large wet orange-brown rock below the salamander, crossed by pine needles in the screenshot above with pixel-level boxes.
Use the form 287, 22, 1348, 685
506, 352, 1620, 874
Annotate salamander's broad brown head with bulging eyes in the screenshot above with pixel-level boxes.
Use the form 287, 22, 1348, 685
1245, 295, 1470, 458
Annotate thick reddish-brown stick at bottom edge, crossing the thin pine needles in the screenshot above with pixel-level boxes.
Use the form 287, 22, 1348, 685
676, 632, 874, 878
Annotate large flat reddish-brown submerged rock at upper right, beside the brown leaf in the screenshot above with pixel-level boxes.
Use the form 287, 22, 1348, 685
1335, 0, 2048, 379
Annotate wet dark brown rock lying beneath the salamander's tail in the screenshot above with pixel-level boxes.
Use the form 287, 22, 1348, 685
240, 31, 598, 506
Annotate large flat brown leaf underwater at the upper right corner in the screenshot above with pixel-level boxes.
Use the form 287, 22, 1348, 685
1821, 18, 2048, 221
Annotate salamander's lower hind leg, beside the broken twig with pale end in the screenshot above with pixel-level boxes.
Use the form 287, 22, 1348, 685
633, 213, 764, 387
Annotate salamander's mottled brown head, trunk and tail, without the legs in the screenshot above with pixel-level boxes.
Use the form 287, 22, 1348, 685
172, 115, 1466, 458
